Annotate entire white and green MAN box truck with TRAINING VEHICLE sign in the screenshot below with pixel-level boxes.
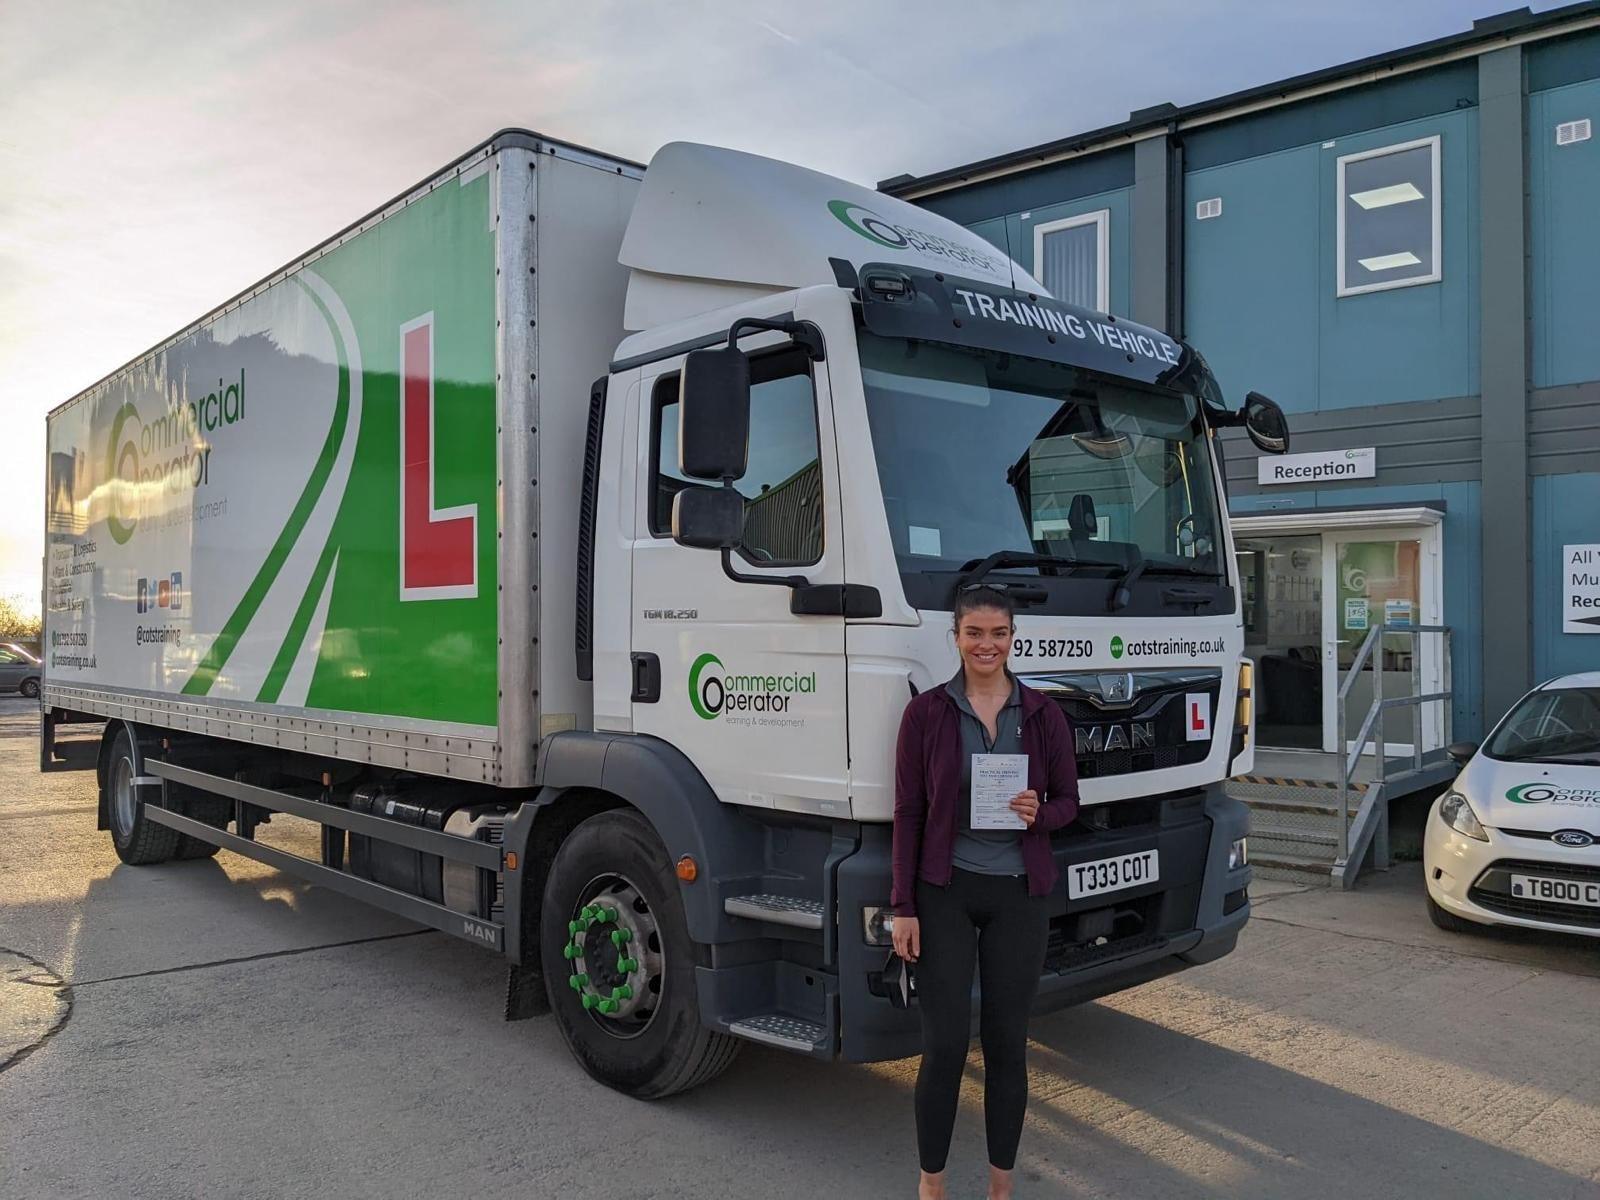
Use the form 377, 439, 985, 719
40, 131, 1288, 1096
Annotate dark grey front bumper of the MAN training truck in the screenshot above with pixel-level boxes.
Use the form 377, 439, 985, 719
837, 784, 1250, 1062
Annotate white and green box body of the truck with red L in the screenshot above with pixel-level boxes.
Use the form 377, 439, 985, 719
45, 138, 640, 787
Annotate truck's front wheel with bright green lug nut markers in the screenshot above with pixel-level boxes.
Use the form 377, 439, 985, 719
539, 810, 741, 1099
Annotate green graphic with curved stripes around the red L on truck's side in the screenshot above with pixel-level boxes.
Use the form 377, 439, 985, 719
184, 176, 499, 725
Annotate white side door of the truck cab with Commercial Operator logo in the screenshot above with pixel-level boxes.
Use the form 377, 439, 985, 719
632, 333, 850, 816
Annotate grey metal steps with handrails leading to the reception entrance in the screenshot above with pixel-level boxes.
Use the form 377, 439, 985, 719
1227, 624, 1456, 888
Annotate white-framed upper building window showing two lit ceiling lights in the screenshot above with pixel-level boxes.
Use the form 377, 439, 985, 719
1338, 136, 1440, 296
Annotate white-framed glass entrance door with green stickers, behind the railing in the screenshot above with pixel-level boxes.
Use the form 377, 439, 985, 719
1322, 525, 1445, 757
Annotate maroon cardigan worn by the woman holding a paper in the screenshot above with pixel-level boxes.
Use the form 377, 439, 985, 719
890, 685, 1078, 917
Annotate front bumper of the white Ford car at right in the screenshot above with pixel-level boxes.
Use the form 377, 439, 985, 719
1422, 802, 1600, 938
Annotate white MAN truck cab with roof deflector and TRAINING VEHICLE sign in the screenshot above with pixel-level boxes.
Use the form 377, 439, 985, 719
579, 146, 1286, 1059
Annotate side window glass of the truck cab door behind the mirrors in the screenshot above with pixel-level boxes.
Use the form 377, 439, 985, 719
650, 347, 822, 566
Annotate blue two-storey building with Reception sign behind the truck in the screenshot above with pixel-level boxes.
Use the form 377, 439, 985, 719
880, 3, 1600, 750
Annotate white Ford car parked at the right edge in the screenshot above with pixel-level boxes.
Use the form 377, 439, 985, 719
1422, 672, 1600, 938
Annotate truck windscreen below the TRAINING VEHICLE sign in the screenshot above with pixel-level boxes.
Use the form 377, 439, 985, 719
861, 330, 1222, 604
